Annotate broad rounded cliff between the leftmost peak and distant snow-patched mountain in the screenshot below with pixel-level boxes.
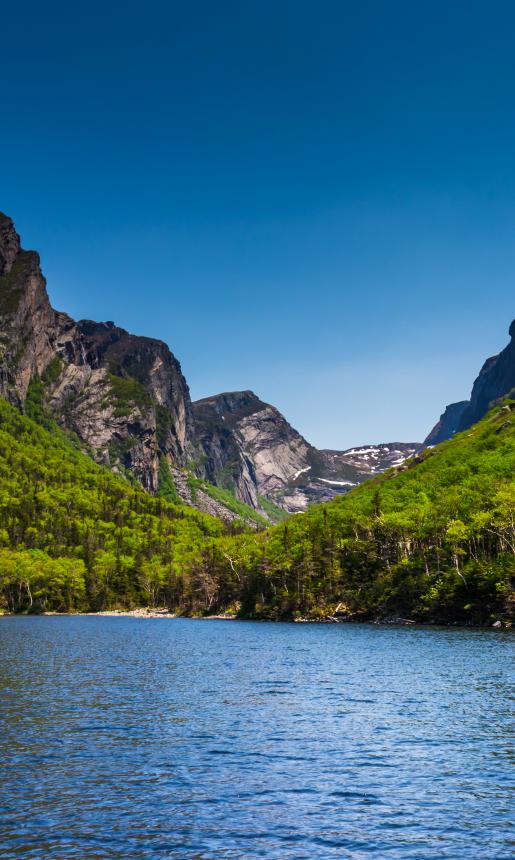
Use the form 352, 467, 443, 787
54, 320, 193, 491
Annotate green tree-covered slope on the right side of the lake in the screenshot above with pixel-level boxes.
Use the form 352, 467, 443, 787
201, 401, 515, 624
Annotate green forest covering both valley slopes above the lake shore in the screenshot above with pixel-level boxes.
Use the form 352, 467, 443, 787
0, 400, 515, 624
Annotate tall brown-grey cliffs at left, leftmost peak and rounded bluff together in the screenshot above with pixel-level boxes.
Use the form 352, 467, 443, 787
0, 216, 193, 491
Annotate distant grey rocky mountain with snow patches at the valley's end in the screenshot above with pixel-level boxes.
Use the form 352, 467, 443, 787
193, 391, 420, 512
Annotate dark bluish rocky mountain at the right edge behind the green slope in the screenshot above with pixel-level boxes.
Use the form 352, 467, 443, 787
424, 320, 515, 445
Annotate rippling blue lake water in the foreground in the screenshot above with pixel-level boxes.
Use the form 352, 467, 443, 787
0, 617, 514, 860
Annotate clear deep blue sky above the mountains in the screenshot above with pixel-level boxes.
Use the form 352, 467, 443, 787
0, 5, 515, 448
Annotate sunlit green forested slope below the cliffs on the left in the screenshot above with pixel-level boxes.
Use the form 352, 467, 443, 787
0, 398, 225, 611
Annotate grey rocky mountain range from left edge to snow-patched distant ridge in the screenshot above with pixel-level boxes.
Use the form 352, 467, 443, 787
0, 214, 419, 526
